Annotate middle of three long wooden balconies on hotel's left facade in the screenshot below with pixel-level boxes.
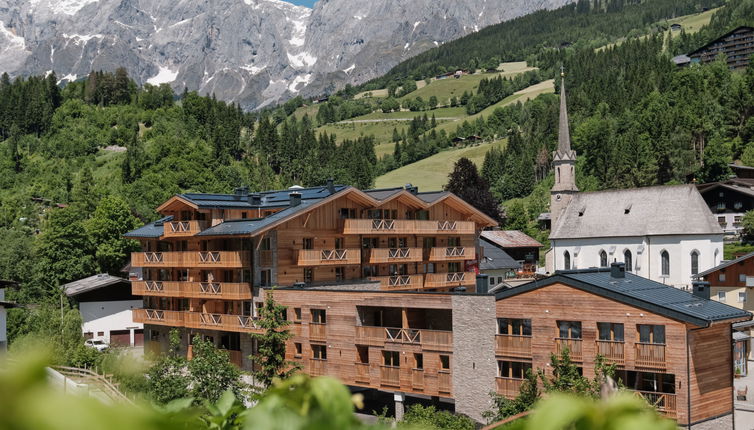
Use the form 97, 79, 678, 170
131, 281, 253, 300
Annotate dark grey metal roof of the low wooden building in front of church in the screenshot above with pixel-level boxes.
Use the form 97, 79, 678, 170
496, 268, 752, 326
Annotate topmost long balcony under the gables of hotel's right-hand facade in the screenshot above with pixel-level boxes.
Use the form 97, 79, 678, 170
343, 219, 476, 235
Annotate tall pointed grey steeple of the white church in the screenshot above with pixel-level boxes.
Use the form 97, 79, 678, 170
550, 67, 579, 230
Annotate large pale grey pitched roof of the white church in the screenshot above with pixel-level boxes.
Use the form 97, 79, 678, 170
550, 185, 723, 239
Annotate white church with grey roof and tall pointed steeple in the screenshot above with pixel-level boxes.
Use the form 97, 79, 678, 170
546, 74, 723, 289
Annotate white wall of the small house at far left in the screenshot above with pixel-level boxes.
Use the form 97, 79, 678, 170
79, 300, 144, 345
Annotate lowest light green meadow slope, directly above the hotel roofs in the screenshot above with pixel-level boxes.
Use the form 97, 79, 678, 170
375, 140, 506, 191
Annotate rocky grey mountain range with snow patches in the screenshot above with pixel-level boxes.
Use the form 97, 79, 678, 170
0, 0, 572, 109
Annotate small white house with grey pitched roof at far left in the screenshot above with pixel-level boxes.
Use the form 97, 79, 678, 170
63, 274, 144, 346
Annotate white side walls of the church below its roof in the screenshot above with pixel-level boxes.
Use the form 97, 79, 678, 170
551, 235, 723, 287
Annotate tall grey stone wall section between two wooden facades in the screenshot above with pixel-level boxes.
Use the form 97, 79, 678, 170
451, 295, 497, 422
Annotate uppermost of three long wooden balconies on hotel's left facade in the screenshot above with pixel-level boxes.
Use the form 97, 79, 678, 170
131, 251, 251, 268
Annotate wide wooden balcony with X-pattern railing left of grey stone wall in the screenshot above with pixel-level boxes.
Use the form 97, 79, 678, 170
356, 326, 453, 351
